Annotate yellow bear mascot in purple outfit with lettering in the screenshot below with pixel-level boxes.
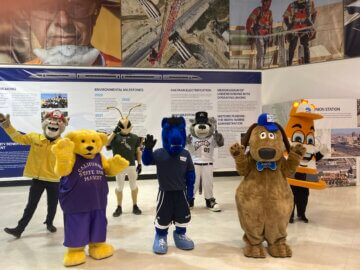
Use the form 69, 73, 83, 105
52, 130, 129, 266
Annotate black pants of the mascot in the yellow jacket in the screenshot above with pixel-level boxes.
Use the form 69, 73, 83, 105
17, 179, 59, 232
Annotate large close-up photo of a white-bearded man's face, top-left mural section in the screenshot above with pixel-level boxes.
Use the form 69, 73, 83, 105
0, 0, 121, 66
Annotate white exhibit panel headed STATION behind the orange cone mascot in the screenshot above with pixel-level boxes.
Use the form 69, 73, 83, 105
263, 99, 360, 188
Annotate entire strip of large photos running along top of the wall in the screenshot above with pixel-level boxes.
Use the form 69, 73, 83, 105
0, 0, 360, 69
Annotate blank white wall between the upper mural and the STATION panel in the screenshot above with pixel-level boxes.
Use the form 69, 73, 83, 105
262, 58, 360, 105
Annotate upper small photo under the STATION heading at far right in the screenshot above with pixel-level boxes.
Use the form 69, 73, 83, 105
331, 128, 360, 157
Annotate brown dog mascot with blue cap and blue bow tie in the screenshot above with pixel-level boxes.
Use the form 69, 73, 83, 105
230, 113, 306, 258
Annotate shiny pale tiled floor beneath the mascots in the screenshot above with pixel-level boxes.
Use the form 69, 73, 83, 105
0, 177, 360, 270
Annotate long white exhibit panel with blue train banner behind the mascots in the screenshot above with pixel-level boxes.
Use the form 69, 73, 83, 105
0, 68, 261, 178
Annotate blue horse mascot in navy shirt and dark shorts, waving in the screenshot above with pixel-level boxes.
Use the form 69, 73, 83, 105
142, 117, 195, 254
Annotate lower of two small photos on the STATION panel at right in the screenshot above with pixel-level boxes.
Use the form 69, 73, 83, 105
316, 158, 357, 187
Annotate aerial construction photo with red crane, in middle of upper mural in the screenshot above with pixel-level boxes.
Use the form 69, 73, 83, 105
121, 0, 229, 69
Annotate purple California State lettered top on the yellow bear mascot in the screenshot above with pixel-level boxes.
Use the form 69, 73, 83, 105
59, 154, 109, 214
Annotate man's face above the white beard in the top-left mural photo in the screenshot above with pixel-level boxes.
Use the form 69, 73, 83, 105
30, 0, 99, 49
